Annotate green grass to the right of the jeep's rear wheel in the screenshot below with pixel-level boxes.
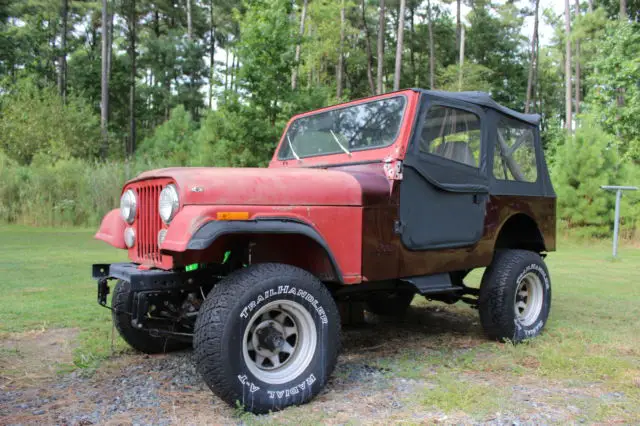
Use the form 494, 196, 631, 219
396, 241, 640, 423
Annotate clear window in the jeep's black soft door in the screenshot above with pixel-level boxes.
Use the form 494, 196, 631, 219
420, 105, 481, 167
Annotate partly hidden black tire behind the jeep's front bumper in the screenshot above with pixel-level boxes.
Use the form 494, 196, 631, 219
111, 280, 191, 354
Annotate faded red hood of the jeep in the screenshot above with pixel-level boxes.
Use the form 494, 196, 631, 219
132, 167, 389, 206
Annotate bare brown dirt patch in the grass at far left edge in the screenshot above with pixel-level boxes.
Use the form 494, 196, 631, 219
0, 328, 78, 389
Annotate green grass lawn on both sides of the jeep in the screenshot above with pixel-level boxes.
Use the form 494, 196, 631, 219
0, 226, 640, 423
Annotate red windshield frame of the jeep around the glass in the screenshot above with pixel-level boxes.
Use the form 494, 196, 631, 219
272, 91, 411, 164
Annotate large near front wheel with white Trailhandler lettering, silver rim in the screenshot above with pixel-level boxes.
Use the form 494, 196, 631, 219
194, 263, 340, 413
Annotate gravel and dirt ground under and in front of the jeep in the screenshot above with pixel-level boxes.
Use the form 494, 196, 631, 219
0, 307, 636, 425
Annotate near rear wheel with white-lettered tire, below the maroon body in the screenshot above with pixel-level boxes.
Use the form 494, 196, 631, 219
478, 250, 551, 343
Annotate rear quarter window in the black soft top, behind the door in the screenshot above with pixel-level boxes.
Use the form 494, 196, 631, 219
493, 117, 538, 182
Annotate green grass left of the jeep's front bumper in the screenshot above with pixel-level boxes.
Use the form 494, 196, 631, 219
0, 225, 126, 367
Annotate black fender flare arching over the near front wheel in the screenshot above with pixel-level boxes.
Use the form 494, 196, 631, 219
187, 218, 343, 283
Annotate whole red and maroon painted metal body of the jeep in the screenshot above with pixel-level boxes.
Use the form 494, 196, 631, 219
96, 90, 555, 284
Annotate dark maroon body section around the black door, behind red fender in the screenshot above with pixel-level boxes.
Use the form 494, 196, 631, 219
336, 163, 556, 281
